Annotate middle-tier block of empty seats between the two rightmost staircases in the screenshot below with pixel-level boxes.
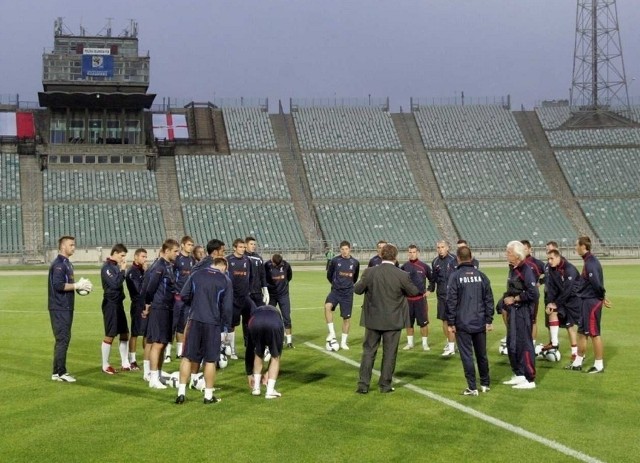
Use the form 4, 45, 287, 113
428, 151, 551, 199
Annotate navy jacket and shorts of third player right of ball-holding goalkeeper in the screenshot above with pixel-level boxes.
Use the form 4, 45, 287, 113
142, 257, 177, 345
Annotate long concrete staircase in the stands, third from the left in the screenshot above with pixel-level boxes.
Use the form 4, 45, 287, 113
269, 113, 322, 252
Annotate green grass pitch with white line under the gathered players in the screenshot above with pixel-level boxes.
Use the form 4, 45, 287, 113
0, 263, 640, 463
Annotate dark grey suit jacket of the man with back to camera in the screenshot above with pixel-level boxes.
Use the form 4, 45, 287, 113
354, 262, 420, 331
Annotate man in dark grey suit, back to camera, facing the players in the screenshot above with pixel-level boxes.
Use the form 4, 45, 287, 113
354, 244, 419, 394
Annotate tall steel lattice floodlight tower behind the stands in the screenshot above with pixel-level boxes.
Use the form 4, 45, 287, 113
565, 0, 634, 128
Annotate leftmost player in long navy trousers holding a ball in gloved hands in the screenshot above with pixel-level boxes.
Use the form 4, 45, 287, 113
47, 237, 75, 379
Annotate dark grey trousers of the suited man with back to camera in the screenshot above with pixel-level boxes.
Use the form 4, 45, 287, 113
358, 328, 401, 390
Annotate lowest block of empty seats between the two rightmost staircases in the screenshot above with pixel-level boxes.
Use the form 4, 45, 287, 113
447, 199, 577, 247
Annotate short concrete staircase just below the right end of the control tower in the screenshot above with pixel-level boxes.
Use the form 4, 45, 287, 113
156, 156, 185, 241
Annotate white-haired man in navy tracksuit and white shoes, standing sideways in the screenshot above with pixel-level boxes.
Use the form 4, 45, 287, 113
498, 241, 539, 389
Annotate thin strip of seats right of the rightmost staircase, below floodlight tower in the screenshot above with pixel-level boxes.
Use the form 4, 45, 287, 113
546, 128, 640, 147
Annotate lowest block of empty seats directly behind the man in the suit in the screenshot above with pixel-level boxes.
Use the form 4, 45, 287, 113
315, 201, 438, 249
